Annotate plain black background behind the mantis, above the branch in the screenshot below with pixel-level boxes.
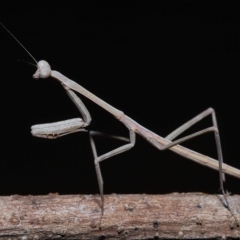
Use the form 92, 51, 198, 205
0, 1, 240, 198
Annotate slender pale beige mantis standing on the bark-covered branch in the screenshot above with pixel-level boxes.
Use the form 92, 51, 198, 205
1, 24, 240, 214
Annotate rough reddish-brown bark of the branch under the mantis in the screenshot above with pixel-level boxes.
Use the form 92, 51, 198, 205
0, 193, 240, 240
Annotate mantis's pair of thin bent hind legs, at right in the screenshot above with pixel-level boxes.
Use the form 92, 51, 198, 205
163, 108, 229, 206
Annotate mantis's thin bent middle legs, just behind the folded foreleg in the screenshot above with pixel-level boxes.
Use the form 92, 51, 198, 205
90, 130, 136, 213
